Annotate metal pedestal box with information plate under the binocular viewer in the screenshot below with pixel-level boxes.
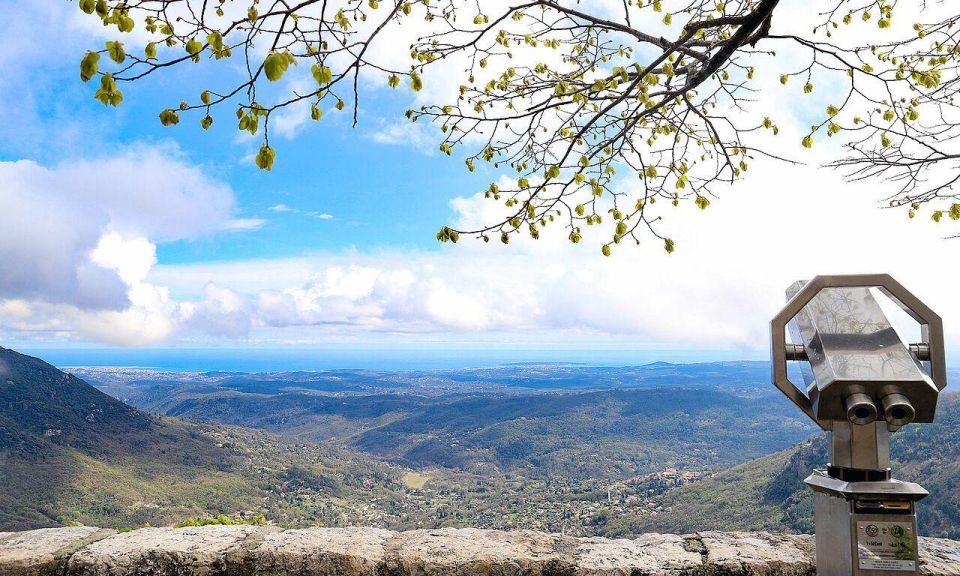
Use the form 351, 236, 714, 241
805, 470, 927, 576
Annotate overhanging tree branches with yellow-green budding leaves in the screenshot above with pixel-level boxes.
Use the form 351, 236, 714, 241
79, 0, 960, 254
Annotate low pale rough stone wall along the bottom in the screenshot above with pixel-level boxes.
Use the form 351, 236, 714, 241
0, 526, 960, 576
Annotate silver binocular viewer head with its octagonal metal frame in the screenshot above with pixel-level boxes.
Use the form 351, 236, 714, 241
770, 274, 947, 430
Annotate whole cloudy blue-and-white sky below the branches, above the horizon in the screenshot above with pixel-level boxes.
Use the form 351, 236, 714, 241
0, 0, 960, 358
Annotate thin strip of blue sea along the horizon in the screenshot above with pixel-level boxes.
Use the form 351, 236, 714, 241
19, 348, 766, 372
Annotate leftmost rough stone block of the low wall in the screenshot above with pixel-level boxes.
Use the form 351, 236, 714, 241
0, 526, 113, 576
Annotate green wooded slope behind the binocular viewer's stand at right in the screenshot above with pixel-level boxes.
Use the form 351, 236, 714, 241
601, 393, 960, 538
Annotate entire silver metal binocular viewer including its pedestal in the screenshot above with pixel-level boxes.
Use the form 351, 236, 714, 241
770, 274, 947, 576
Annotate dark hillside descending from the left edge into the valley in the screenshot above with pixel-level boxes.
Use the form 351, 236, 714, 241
0, 348, 416, 530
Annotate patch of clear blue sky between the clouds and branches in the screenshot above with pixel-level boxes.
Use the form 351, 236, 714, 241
0, 7, 491, 263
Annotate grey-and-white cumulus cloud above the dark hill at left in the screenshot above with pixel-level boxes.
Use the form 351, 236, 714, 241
0, 146, 263, 345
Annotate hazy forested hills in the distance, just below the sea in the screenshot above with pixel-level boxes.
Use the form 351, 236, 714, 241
80, 362, 814, 482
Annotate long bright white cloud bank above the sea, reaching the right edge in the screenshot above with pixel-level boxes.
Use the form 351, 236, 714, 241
141, 155, 960, 353
